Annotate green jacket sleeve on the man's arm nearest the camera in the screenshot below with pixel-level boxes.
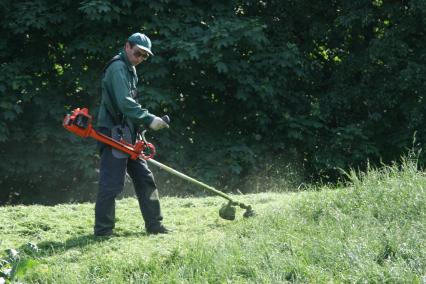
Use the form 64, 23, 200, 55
110, 69, 155, 126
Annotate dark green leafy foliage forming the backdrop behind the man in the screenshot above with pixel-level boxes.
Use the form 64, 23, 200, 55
0, 0, 426, 203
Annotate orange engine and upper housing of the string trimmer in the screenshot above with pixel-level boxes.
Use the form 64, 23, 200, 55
62, 108, 156, 160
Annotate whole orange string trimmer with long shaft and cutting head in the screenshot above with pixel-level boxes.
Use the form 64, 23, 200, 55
63, 108, 255, 220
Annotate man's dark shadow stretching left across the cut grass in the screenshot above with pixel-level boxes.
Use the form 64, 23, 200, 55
19, 231, 147, 257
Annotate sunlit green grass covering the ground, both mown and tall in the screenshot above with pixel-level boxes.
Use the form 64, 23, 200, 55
0, 161, 426, 283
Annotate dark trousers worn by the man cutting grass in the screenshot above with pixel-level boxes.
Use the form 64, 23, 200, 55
94, 146, 163, 235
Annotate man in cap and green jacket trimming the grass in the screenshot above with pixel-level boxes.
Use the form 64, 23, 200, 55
94, 33, 169, 236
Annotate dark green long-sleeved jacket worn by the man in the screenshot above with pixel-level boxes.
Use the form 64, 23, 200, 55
97, 50, 155, 136
